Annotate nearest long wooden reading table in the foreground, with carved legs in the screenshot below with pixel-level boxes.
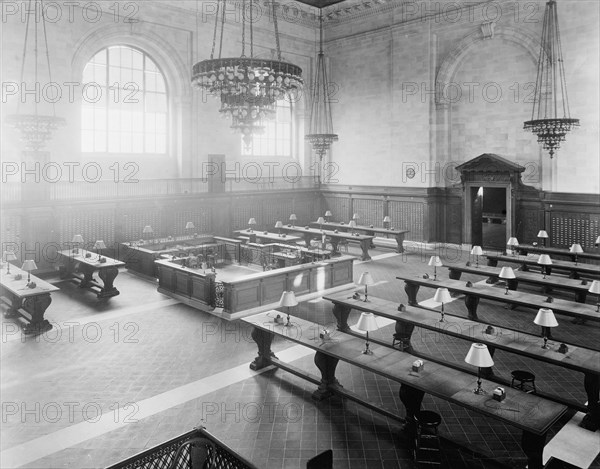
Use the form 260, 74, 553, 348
242, 311, 567, 467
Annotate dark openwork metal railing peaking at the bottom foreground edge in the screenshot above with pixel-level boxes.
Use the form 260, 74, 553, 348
106, 427, 258, 469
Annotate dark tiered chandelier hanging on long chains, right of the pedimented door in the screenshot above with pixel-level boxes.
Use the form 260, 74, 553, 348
523, 0, 579, 158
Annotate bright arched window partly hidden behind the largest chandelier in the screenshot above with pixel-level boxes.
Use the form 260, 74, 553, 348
241, 99, 293, 157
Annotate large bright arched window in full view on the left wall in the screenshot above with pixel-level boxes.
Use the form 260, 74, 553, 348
81, 46, 168, 154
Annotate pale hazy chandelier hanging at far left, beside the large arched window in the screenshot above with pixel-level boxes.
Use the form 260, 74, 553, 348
5, 0, 65, 151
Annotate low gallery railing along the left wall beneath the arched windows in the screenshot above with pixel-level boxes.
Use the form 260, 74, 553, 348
1, 177, 315, 203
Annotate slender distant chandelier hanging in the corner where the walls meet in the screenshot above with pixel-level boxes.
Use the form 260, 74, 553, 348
304, 9, 338, 184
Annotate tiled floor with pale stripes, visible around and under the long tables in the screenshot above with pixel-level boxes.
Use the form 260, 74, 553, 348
0, 246, 600, 469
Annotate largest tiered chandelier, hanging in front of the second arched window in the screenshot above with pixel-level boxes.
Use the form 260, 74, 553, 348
192, 0, 303, 146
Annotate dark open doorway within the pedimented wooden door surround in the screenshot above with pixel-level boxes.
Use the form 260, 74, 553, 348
470, 186, 508, 250
